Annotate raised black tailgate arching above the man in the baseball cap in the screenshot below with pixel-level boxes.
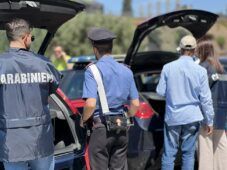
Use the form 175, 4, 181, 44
125, 10, 218, 66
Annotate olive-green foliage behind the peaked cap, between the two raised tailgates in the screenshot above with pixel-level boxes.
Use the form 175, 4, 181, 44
46, 13, 135, 56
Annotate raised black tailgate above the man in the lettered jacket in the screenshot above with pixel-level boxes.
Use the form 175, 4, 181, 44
0, 0, 85, 54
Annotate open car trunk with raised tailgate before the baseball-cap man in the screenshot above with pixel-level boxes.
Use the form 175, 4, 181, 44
125, 10, 218, 123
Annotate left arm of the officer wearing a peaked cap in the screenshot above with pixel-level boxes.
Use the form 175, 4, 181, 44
81, 69, 98, 125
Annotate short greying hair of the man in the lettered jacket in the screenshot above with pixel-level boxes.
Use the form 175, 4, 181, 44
5, 18, 32, 41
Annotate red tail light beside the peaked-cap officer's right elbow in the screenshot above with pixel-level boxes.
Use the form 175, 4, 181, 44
135, 102, 155, 119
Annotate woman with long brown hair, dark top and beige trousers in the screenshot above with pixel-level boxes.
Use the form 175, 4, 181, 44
196, 39, 227, 170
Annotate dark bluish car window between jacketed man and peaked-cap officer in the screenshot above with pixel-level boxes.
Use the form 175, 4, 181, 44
59, 70, 84, 100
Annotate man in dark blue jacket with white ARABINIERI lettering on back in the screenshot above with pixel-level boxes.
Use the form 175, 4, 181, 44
0, 19, 60, 170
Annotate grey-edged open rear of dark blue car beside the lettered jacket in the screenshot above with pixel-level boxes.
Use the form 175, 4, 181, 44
49, 94, 84, 170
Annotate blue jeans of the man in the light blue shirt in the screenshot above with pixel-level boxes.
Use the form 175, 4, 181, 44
162, 122, 200, 170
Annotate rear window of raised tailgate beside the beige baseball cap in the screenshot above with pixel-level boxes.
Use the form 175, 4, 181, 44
139, 26, 190, 52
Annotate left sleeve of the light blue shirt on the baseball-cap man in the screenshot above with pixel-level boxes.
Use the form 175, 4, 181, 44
156, 66, 167, 97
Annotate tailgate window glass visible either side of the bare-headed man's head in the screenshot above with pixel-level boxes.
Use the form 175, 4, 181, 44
0, 28, 47, 53
